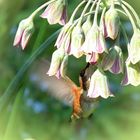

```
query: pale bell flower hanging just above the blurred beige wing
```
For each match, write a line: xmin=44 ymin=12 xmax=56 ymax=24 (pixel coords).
xmin=47 ymin=48 xmax=67 ymax=78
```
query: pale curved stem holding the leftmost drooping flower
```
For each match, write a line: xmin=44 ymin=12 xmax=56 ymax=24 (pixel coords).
xmin=29 ymin=0 xmax=56 ymax=19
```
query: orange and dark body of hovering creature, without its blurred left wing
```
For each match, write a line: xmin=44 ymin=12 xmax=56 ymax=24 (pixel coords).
xmin=66 ymin=63 xmax=98 ymax=120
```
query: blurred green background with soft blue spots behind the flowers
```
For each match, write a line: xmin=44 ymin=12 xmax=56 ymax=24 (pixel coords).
xmin=0 ymin=0 xmax=140 ymax=140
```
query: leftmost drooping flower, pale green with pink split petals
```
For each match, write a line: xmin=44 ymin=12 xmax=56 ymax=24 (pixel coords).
xmin=13 ymin=17 xmax=34 ymax=50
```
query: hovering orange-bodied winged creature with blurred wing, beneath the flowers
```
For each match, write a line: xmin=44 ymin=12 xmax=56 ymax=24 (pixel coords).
xmin=30 ymin=60 xmax=98 ymax=121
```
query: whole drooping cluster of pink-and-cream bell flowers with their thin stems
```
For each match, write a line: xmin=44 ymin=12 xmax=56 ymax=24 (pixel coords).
xmin=14 ymin=0 xmax=140 ymax=113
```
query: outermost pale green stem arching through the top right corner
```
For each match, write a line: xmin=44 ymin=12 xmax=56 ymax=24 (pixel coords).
xmin=122 ymin=0 xmax=140 ymax=26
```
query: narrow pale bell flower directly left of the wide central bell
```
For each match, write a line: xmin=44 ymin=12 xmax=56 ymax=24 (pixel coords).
xmin=70 ymin=25 xmax=85 ymax=58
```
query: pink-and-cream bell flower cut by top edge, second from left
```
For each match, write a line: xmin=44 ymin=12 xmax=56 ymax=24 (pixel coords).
xmin=41 ymin=0 xmax=67 ymax=25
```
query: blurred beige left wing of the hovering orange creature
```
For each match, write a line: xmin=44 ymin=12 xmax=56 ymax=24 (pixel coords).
xmin=30 ymin=60 xmax=74 ymax=106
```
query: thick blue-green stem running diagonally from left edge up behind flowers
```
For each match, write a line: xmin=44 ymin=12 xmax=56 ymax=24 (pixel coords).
xmin=0 ymin=30 xmax=60 ymax=113
